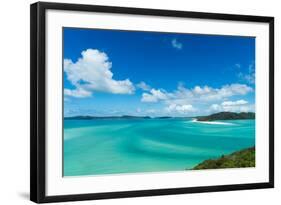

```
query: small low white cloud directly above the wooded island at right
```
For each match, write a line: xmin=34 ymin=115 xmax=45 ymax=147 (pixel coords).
xmin=209 ymin=100 xmax=255 ymax=112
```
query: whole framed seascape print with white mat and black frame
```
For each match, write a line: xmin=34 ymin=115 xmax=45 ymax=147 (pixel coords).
xmin=30 ymin=2 xmax=274 ymax=203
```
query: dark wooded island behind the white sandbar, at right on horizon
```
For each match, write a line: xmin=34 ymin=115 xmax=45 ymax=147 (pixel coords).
xmin=195 ymin=112 xmax=255 ymax=121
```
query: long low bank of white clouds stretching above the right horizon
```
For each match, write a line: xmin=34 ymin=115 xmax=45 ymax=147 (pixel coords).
xmin=141 ymin=84 xmax=253 ymax=114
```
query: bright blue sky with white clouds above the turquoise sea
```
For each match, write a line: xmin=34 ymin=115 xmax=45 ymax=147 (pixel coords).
xmin=63 ymin=28 xmax=255 ymax=116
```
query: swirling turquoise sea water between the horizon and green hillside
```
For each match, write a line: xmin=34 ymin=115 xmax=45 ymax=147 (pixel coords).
xmin=64 ymin=119 xmax=255 ymax=176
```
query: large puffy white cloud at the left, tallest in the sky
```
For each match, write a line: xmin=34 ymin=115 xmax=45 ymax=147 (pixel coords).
xmin=64 ymin=49 xmax=135 ymax=97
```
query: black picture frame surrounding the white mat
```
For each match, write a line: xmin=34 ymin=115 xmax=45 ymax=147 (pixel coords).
xmin=30 ymin=2 xmax=274 ymax=203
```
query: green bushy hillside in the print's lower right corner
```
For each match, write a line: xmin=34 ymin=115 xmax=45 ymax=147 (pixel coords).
xmin=192 ymin=147 xmax=255 ymax=170
